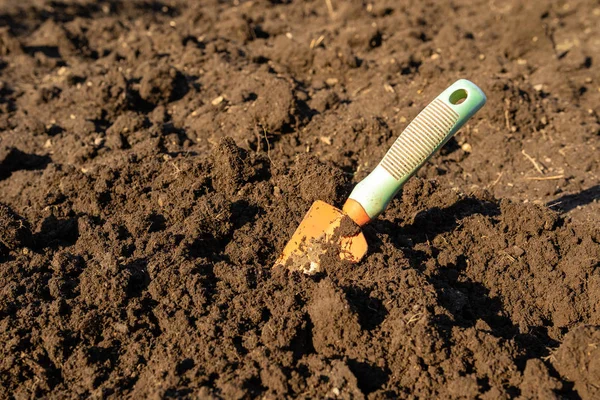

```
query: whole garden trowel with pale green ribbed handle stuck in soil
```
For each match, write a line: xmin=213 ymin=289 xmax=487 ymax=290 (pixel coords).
xmin=275 ymin=79 xmax=486 ymax=275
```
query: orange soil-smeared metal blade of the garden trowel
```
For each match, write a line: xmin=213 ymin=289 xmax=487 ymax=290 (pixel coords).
xmin=275 ymin=200 xmax=367 ymax=275
